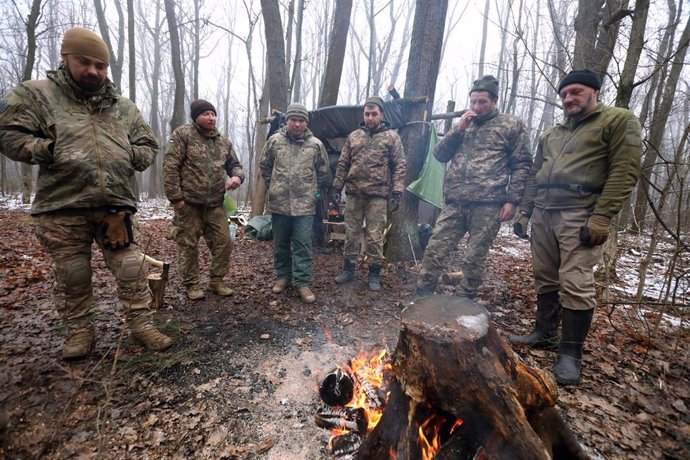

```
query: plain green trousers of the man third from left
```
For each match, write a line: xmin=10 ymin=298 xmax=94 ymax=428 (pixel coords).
xmin=271 ymin=213 xmax=314 ymax=287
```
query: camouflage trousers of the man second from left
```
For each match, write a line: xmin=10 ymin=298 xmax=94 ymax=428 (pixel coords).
xmin=173 ymin=203 xmax=230 ymax=288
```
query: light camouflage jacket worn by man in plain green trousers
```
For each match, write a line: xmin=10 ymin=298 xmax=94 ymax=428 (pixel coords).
xmin=259 ymin=127 xmax=332 ymax=216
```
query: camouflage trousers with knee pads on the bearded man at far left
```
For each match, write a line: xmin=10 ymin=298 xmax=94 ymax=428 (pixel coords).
xmin=33 ymin=209 xmax=151 ymax=328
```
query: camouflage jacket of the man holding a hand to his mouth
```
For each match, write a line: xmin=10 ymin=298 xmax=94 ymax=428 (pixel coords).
xmin=434 ymin=111 xmax=532 ymax=205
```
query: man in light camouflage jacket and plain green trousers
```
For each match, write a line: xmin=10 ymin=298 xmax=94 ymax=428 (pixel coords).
xmin=259 ymin=103 xmax=332 ymax=303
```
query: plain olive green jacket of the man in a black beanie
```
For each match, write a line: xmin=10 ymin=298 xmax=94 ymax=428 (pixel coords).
xmin=520 ymin=104 xmax=642 ymax=217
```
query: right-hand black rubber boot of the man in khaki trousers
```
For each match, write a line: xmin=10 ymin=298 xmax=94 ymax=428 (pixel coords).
xmin=553 ymin=308 xmax=594 ymax=385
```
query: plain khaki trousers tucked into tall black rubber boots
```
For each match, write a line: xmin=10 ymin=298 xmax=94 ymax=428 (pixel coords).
xmin=530 ymin=208 xmax=603 ymax=310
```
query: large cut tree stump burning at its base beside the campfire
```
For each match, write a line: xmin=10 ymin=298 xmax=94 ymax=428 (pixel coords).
xmin=359 ymin=296 xmax=587 ymax=460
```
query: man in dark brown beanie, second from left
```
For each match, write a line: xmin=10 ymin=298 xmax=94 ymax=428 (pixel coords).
xmin=163 ymin=99 xmax=244 ymax=300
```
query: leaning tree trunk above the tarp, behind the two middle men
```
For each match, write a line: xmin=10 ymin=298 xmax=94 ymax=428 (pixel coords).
xmin=319 ymin=0 xmax=352 ymax=107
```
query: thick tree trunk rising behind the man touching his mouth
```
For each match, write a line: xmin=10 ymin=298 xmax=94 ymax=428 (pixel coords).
xmin=386 ymin=0 xmax=448 ymax=261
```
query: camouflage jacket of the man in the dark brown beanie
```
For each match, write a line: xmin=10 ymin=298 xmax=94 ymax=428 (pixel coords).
xmin=163 ymin=122 xmax=244 ymax=207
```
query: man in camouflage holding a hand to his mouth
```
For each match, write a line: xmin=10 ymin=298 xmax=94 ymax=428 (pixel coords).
xmin=416 ymin=75 xmax=532 ymax=297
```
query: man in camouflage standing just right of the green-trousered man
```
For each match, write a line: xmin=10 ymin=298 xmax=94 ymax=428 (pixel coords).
xmin=332 ymin=96 xmax=405 ymax=291
